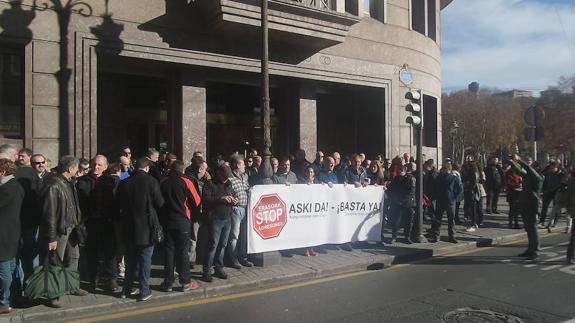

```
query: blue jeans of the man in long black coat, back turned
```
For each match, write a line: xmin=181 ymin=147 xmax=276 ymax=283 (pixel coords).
xmin=123 ymin=245 xmax=154 ymax=295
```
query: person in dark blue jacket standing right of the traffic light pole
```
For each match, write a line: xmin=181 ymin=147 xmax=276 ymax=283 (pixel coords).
xmin=429 ymin=163 xmax=463 ymax=243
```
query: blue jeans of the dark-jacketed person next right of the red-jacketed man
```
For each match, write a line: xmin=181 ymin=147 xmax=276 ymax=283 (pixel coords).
xmin=204 ymin=217 xmax=231 ymax=274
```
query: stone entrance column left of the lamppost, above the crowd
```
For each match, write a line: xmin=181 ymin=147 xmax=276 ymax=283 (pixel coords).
xmin=180 ymin=75 xmax=207 ymax=164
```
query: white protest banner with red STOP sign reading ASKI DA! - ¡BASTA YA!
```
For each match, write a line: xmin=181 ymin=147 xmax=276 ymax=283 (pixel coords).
xmin=247 ymin=184 xmax=384 ymax=253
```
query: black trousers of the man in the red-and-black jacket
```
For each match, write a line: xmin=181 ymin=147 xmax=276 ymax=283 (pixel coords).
xmin=164 ymin=225 xmax=191 ymax=286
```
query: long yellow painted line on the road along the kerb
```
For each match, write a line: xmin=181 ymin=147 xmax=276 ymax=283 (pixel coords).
xmin=69 ymin=234 xmax=564 ymax=323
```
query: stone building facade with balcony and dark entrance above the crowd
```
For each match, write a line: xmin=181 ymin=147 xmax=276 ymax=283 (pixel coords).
xmin=0 ymin=0 xmax=451 ymax=166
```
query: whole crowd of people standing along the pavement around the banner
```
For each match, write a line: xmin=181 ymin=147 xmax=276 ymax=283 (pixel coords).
xmin=0 ymin=144 xmax=575 ymax=313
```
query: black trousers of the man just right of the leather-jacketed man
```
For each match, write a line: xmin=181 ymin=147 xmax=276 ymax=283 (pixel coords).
xmin=86 ymin=219 xmax=118 ymax=283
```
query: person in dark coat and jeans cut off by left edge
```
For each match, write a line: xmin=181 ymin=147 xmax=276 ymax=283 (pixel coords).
xmin=0 ymin=159 xmax=24 ymax=314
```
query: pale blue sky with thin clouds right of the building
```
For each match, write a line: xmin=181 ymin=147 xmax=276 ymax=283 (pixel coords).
xmin=442 ymin=0 xmax=575 ymax=91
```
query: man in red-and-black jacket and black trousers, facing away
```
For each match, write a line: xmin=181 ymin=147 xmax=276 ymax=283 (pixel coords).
xmin=161 ymin=160 xmax=201 ymax=292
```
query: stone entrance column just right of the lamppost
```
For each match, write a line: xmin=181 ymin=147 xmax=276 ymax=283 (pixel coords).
xmin=299 ymin=84 xmax=317 ymax=158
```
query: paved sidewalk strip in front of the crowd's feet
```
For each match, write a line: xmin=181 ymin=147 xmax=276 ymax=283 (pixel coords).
xmin=0 ymin=198 xmax=565 ymax=323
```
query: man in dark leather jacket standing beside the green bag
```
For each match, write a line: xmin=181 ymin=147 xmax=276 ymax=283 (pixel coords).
xmin=40 ymin=156 xmax=88 ymax=307
